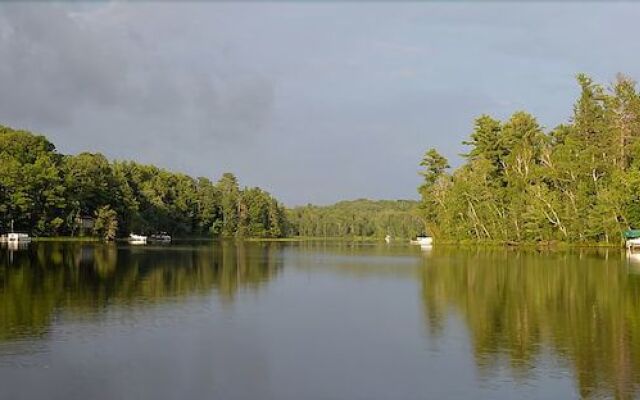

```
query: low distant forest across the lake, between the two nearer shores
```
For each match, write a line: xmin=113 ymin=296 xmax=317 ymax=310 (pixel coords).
xmin=287 ymin=199 xmax=424 ymax=238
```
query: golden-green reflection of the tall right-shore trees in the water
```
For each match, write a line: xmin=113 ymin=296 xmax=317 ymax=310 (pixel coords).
xmin=422 ymin=248 xmax=640 ymax=398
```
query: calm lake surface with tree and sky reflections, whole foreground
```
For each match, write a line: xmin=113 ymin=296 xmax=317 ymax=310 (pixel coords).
xmin=0 ymin=242 xmax=640 ymax=400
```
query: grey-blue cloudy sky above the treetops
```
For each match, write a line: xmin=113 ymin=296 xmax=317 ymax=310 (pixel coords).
xmin=0 ymin=1 xmax=640 ymax=206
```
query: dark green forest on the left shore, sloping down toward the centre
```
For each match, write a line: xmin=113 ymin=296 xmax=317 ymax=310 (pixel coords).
xmin=0 ymin=125 xmax=286 ymax=239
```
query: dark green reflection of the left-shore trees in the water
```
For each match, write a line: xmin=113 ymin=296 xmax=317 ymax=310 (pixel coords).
xmin=0 ymin=241 xmax=281 ymax=341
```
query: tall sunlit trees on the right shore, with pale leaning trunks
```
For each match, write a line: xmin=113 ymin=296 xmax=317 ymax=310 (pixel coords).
xmin=419 ymin=74 xmax=640 ymax=243
